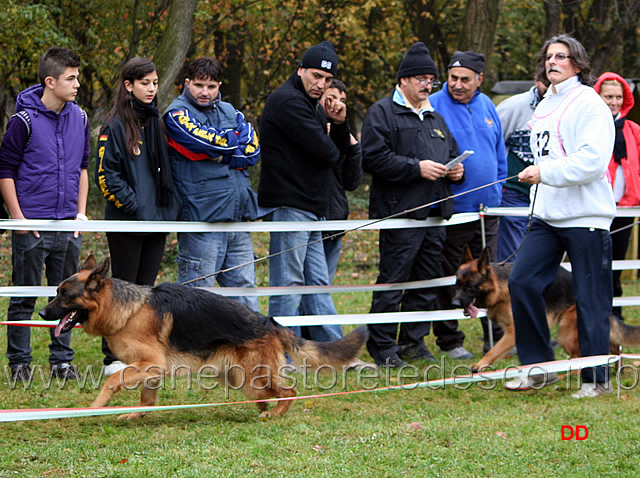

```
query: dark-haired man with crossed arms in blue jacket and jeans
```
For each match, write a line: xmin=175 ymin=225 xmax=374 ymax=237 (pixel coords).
xmin=164 ymin=57 xmax=260 ymax=311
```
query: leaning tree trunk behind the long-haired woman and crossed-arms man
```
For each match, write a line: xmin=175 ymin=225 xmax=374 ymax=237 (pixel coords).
xmin=154 ymin=0 xmax=198 ymax=111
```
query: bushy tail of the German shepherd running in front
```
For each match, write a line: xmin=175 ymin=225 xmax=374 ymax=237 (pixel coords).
xmin=276 ymin=325 xmax=369 ymax=369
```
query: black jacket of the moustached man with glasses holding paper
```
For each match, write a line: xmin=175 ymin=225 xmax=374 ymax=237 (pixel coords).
xmin=362 ymin=92 xmax=462 ymax=219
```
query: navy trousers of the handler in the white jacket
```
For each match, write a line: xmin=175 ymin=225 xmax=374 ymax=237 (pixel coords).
xmin=509 ymin=219 xmax=613 ymax=383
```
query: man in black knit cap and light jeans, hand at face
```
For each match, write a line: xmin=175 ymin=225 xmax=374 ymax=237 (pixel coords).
xmin=258 ymin=41 xmax=350 ymax=341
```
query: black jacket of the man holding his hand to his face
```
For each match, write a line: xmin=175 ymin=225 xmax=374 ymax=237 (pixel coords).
xmin=258 ymin=71 xmax=349 ymax=217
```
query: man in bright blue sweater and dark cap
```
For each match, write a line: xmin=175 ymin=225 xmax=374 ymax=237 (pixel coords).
xmin=431 ymin=51 xmax=507 ymax=358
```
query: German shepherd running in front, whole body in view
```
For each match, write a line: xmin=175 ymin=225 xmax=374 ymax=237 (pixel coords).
xmin=40 ymin=254 xmax=367 ymax=419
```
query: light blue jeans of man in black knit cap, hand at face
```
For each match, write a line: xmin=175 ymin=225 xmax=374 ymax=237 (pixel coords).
xmin=265 ymin=207 xmax=342 ymax=342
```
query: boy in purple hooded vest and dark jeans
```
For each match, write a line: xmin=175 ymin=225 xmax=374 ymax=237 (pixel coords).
xmin=0 ymin=47 xmax=89 ymax=382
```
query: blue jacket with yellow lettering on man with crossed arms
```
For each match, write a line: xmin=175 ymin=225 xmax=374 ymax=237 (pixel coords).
xmin=164 ymin=94 xmax=260 ymax=222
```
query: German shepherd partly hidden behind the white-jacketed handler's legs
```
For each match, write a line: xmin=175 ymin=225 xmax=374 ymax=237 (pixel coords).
xmin=452 ymin=247 xmax=640 ymax=371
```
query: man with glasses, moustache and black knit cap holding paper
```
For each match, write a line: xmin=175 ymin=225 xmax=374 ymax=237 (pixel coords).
xmin=362 ymin=42 xmax=464 ymax=367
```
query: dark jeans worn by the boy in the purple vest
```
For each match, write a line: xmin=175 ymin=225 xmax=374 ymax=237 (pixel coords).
xmin=7 ymin=231 xmax=82 ymax=368
